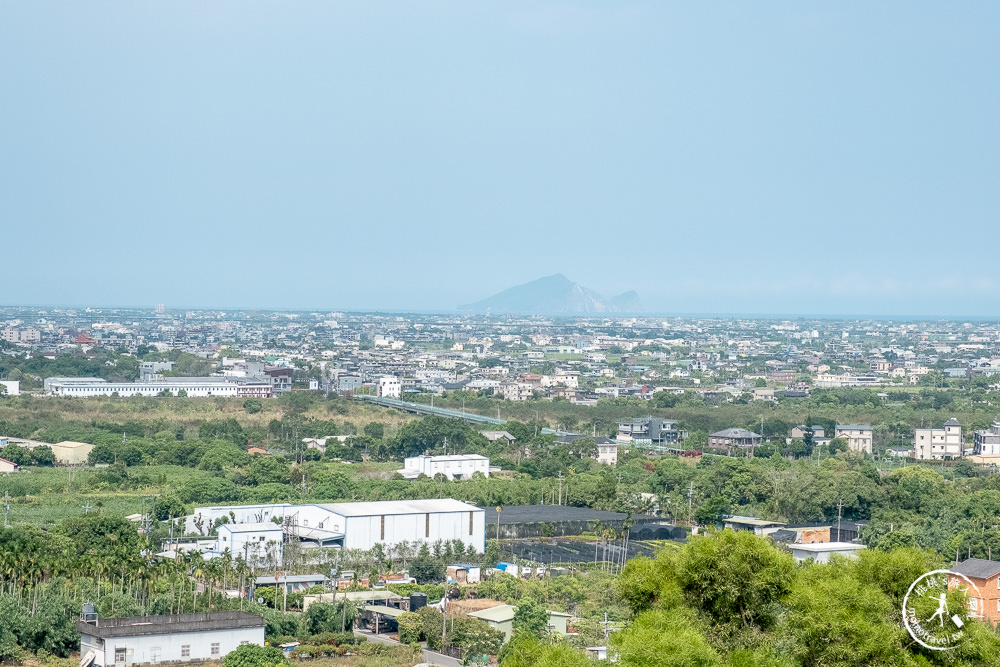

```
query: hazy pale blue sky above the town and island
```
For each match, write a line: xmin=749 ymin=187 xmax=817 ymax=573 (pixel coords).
xmin=0 ymin=0 xmax=1000 ymax=316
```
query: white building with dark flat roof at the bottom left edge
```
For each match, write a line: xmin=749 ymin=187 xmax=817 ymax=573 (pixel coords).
xmin=76 ymin=605 xmax=264 ymax=667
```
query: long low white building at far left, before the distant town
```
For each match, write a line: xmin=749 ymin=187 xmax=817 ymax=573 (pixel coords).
xmin=42 ymin=376 xmax=272 ymax=398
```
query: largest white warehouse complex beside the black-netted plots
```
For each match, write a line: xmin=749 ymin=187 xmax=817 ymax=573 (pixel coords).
xmin=185 ymin=498 xmax=486 ymax=556
